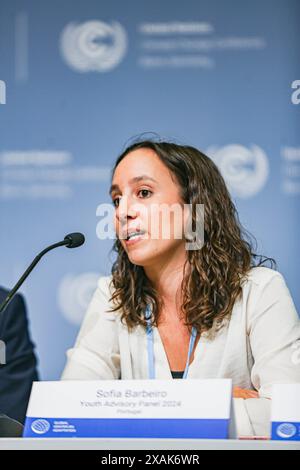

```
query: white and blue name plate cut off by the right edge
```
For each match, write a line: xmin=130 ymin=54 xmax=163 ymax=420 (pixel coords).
xmin=271 ymin=383 xmax=300 ymax=441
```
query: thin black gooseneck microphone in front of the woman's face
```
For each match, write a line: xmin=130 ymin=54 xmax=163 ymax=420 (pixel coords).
xmin=0 ymin=232 xmax=85 ymax=315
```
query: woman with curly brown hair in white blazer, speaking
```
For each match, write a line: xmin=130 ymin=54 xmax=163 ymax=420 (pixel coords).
xmin=62 ymin=141 xmax=300 ymax=435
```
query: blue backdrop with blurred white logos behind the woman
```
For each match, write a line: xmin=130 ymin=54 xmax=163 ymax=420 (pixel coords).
xmin=0 ymin=0 xmax=300 ymax=380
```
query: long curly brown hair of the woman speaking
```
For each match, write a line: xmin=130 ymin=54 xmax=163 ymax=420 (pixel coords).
xmin=109 ymin=140 xmax=276 ymax=334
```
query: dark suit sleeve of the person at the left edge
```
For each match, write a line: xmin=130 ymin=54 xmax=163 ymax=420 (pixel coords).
xmin=0 ymin=288 xmax=38 ymax=423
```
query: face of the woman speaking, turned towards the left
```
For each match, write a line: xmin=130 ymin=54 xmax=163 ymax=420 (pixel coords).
xmin=111 ymin=148 xmax=185 ymax=267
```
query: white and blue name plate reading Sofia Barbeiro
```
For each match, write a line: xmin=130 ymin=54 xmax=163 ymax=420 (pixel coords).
xmin=23 ymin=379 xmax=232 ymax=439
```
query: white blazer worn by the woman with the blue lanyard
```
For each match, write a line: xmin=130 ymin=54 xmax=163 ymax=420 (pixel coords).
xmin=62 ymin=267 xmax=300 ymax=436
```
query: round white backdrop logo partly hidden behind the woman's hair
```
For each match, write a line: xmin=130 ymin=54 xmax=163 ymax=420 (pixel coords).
xmin=207 ymin=144 xmax=269 ymax=198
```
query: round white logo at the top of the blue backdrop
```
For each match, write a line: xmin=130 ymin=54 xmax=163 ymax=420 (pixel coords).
xmin=60 ymin=20 xmax=127 ymax=72
